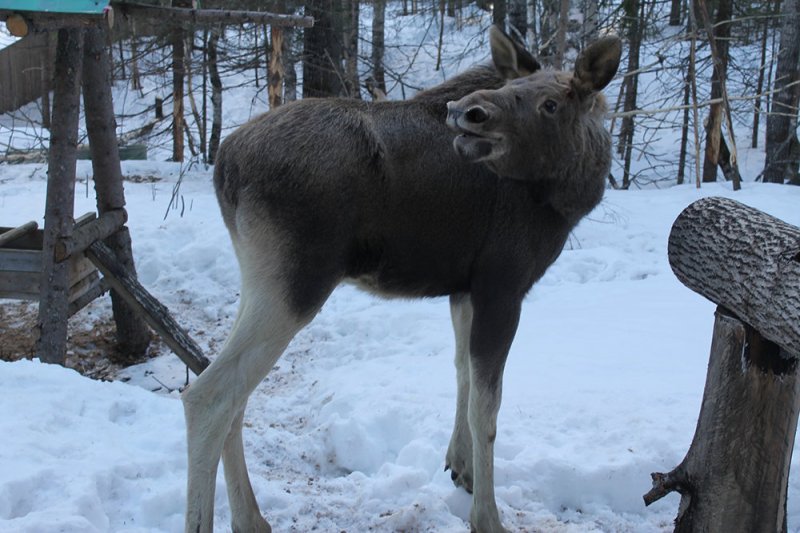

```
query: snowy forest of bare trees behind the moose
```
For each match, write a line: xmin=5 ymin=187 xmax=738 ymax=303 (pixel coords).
xmin=0 ymin=0 xmax=800 ymax=189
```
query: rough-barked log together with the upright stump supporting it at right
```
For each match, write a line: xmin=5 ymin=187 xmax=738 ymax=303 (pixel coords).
xmin=644 ymin=198 xmax=800 ymax=533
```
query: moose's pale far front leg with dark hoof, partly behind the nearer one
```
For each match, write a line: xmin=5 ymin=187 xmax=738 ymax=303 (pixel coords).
xmin=445 ymin=294 xmax=472 ymax=493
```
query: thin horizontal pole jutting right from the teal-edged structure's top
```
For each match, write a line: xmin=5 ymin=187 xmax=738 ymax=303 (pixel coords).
xmin=113 ymin=2 xmax=314 ymax=28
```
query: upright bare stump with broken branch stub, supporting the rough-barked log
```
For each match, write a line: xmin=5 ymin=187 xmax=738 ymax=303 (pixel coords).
xmin=644 ymin=308 xmax=800 ymax=533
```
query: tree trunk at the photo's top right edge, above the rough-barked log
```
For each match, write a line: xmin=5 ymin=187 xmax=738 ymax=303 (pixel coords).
xmin=764 ymin=0 xmax=800 ymax=183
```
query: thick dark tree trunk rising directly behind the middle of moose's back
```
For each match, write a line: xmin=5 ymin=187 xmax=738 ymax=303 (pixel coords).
xmin=303 ymin=0 xmax=344 ymax=98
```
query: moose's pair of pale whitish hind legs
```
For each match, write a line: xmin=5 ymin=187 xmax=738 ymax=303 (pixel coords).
xmin=183 ymin=268 xmax=321 ymax=533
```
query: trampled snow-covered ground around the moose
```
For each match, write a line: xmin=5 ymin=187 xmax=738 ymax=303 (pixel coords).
xmin=0 ymin=162 xmax=800 ymax=533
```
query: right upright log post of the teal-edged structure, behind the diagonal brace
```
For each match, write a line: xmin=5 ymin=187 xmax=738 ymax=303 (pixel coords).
xmin=83 ymin=28 xmax=150 ymax=361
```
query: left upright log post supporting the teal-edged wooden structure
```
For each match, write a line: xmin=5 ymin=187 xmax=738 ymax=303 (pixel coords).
xmin=36 ymin=28 xmax=83 ymax=364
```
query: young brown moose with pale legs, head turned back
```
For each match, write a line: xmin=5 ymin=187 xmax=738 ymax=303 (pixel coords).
xmin=182 ymin=27 xmax=621 ymax=533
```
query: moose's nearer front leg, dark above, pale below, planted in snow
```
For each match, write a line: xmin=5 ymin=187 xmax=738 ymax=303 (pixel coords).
xmin=467 ymin=293 xmax=521 ymax=533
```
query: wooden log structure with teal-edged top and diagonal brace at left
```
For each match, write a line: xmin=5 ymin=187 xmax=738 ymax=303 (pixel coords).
xmin=0 ymin=0 xmax=313 ymax=373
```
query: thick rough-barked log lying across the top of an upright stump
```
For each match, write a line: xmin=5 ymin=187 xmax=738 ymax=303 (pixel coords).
xmin=668 ymin=198 xmax=800 ymax=357
